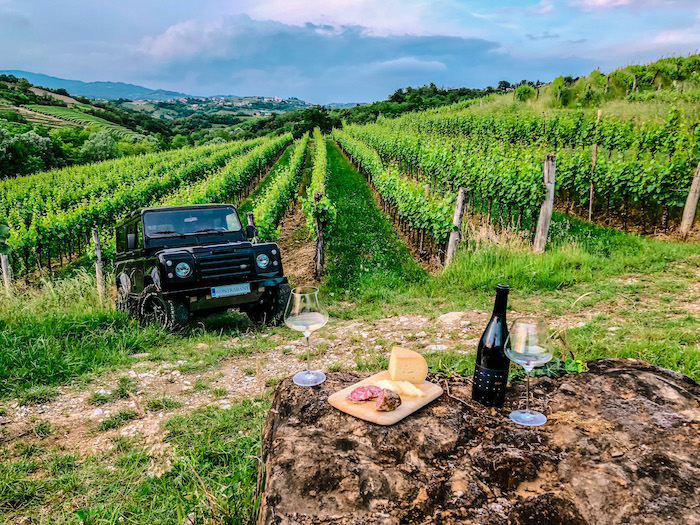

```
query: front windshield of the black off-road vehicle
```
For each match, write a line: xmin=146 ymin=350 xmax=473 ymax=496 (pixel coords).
xmin=143 ymin=208 xmax=241 ymax=237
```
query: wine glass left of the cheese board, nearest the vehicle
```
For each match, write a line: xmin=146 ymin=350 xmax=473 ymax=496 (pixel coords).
xmin=284 ymin=286 xmax=328 ymax=386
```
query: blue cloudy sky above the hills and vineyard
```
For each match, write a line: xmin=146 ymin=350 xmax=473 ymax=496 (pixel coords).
xmin=0 ymin=0 xmax=700 ymax=103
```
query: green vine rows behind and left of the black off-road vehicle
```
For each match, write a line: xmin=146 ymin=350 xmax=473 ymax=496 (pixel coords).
xmin=5 ymin=135 xmax=291 ymax=275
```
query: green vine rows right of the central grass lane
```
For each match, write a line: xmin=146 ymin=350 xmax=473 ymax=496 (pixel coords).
xmin=335 ymin=102 xmax=700 ymax=254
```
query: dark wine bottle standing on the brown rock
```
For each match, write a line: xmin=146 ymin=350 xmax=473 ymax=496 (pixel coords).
xmin=472 ymin=284 xmax=510 ymax=406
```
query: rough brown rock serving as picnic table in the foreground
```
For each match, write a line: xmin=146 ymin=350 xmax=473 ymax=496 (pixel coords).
xmin=258 ymin=359 xmax=700 ymax=525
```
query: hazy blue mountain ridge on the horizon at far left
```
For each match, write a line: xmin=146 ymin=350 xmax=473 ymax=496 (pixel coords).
xmin=0 ymin=70 xmax=191 ymax=100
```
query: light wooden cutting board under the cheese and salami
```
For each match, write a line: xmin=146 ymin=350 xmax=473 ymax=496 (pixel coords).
xmin=328 ymin=370 xmax=442 ymax=425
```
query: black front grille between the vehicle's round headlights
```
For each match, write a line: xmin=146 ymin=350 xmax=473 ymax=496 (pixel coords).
xmin=193 ymin=248 xmax=255 ymax=283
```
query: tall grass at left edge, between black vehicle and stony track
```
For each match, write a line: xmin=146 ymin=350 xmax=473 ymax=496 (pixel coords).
xmin=0 ymin=272 xmax=172 ymax=403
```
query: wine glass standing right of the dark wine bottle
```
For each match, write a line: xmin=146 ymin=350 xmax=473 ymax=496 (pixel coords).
xmin=506 ymin=317 xmax=553 ymax=427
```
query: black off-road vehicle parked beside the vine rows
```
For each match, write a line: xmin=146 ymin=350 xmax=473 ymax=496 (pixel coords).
xmin=115 ymin=204 xmax=290 ymax=330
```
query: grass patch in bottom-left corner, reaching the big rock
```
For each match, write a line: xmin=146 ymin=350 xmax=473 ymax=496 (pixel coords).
xmin=0 ymin=400 xmax=269 ymax=525
